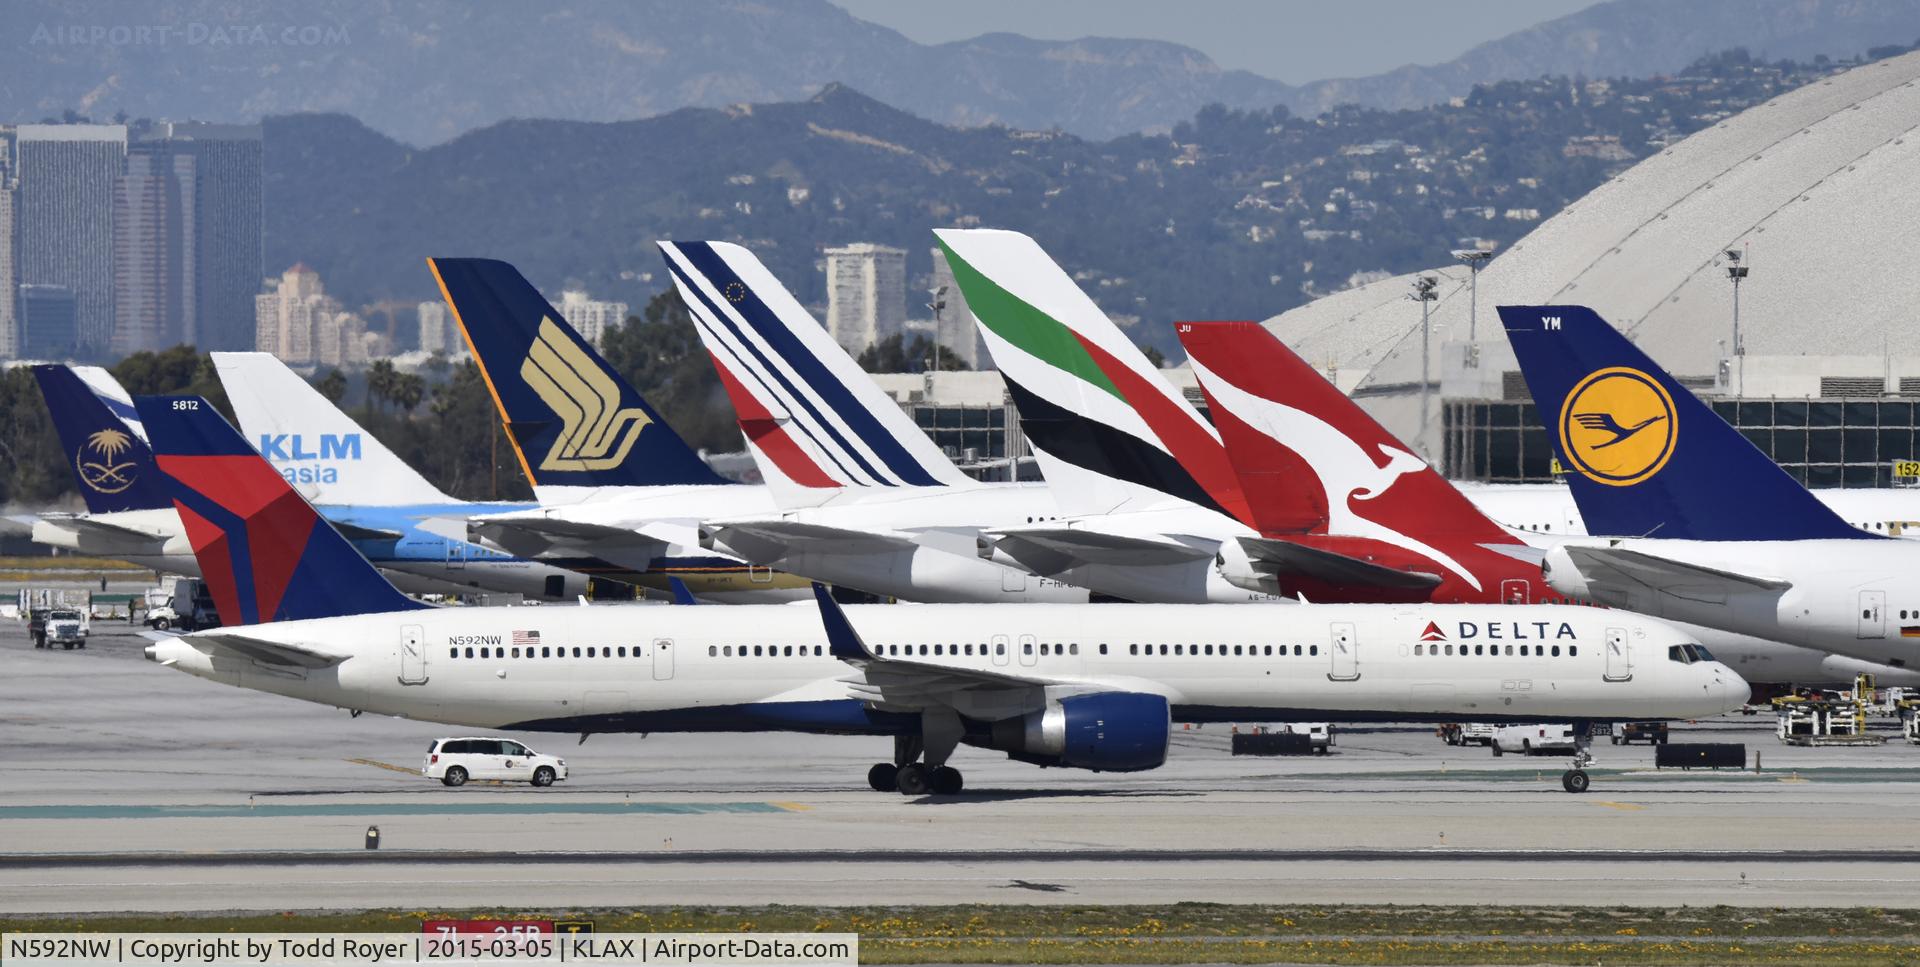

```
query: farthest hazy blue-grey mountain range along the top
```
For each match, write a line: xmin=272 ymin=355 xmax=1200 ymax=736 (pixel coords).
xmin=15 ymin=0 xmax=1920 ymax=144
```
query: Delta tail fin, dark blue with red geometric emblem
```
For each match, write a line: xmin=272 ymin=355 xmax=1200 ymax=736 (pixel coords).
xmin=134 ymin=397 xmax=424 ymax=624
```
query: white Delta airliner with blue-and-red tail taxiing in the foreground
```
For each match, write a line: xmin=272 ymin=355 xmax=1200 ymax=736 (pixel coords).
xmin=136 ymin=397 xmax=1745 ymax=792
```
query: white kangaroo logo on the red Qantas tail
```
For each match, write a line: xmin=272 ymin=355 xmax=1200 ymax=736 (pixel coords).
xmin=1192 ymin=361 xmax=1480 ymax=591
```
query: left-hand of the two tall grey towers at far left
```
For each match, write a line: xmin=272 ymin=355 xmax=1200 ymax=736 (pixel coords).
xmin=13 ymin=125 xmax=127 ymax=355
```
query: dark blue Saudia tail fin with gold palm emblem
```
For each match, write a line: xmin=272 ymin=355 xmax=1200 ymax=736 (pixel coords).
xmin=33 ymin=366 xmax=173 ymax=514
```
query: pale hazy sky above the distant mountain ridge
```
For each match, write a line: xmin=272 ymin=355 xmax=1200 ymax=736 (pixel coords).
xmin=833 ymin=0 xmax=1596 ymax=84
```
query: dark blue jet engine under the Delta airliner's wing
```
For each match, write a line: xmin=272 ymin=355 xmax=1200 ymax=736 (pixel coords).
xmin=987 ymin=693 xmax=1173 ymax=771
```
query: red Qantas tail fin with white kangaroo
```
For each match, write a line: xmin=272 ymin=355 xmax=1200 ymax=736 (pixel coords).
xmin=1177 ymin=322 xmax=1517 ymax=543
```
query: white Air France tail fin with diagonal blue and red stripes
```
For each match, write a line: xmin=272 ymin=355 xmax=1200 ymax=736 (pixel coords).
xmin=660 ymin=242 xmax=975 ymax=487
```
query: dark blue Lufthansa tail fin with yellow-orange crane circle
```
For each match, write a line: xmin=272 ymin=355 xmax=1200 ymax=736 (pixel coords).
xmin=1500 ymin=305 xmax=1872 ymax=541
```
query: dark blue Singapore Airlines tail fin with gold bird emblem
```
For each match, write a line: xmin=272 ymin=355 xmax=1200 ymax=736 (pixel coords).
xmin=426 ymin=259 xmax=726 ymax=487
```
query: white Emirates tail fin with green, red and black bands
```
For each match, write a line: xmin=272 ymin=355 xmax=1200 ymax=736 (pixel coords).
xmin=933 ymin=228 xmax=1254 ymax=526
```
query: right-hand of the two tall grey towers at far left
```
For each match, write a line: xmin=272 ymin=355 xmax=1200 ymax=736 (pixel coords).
xmin=113 ymin=121 xmax=261 ymax=351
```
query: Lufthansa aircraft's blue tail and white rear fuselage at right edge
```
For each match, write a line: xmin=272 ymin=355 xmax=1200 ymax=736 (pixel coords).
xmin=1500 ymin=305 xmax=1920 ymax=668
